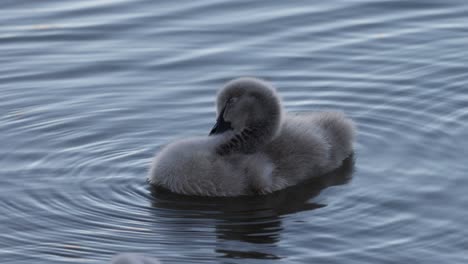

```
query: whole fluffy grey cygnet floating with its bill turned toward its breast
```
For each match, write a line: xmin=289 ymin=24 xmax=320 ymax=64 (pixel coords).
xmin=149 ymin=78 xmax=354 ymax=196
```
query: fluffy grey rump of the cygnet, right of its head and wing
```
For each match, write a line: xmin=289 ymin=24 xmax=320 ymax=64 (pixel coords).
xmin=262 ymin=112 xmax=354 ymax=190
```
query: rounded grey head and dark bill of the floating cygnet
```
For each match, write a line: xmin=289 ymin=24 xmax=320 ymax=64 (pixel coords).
xmin=210 ymin=78 xmax=282 ymax=155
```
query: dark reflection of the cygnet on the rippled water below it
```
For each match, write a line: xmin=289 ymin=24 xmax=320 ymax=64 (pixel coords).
xmin=151 ymin=156 xmax=354 ymax=259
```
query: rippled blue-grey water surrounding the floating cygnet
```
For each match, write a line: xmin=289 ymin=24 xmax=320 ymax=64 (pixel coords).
xmin=0 ymin=0 xmax=468 ymax=264
